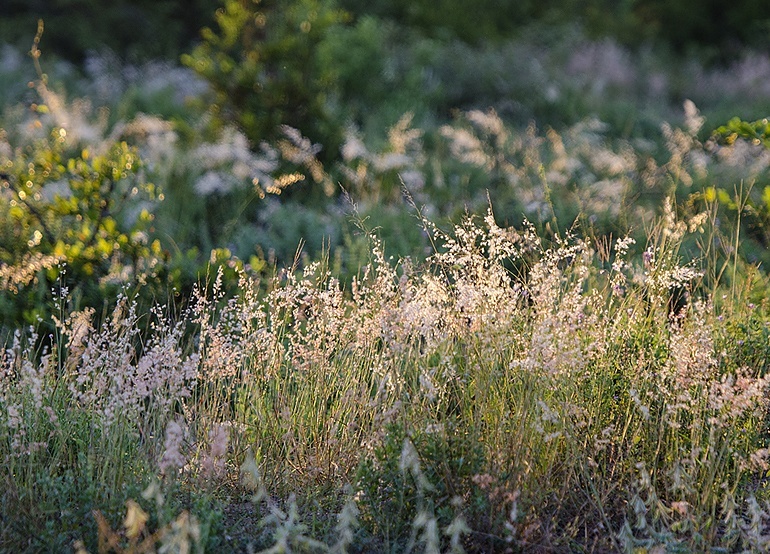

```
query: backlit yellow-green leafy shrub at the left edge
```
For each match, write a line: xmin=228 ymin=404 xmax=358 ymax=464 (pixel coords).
xmin=0 ymin=125 xmax=164 ymax=326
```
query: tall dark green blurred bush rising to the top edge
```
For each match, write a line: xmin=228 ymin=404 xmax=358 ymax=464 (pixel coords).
xmin=182 ymin=0 xmax=346 ymax=159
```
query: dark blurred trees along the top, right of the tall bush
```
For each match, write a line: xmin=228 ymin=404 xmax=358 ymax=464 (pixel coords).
xmin=340 ymin=0 xmax=770 ymax=54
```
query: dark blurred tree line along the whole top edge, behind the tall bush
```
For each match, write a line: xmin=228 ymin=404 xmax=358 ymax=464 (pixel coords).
xmin=0 ymin=0 xmax=770 ymax=62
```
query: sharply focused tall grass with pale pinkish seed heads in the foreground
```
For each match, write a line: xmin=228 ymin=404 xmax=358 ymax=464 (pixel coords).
xmin=0 ymin=196 xmax=770 ymax=552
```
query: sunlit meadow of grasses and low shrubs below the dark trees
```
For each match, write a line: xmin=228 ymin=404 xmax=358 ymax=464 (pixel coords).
xmin=0 ymin=7 xmax=770 ymax=554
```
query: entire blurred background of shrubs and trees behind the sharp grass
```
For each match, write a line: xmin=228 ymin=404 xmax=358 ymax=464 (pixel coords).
xmin=0 ymin=0 xmax=770 ymax=324
